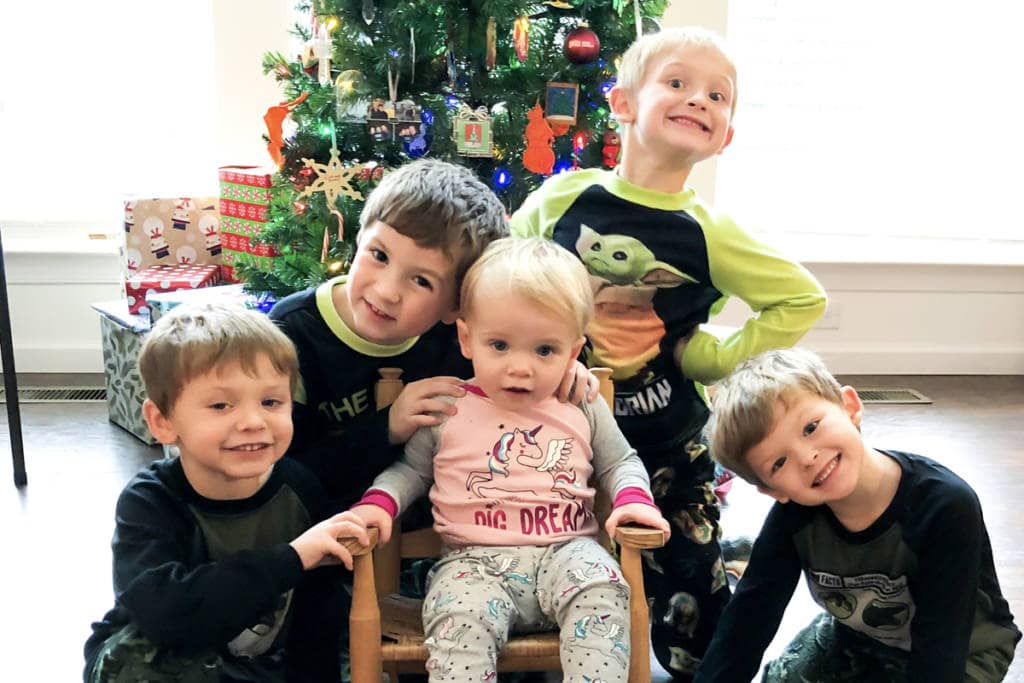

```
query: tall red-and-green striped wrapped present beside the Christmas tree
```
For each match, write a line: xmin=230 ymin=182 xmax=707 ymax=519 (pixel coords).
xmin=219 ymin=166 xmax=280 ymax=282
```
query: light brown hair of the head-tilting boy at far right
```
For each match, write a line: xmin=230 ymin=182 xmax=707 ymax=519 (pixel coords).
xmin=707 ymin=348 xmax=843 ymax=487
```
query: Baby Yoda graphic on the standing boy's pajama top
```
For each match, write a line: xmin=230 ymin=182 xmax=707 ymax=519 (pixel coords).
xmin=575 ymin=223 xmax=697 ymax=381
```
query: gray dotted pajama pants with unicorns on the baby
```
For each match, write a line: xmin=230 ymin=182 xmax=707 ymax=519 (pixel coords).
xmin=423 ymin=539 xmax=630 ymax=683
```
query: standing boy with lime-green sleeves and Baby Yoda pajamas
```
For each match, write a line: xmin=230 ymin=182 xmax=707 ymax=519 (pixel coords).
xmin=512 ymin=28 xmax=825 ymax=680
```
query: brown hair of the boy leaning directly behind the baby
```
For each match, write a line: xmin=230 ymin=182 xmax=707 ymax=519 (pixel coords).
xmin=356 ymin=159 xmax=509 ymax=301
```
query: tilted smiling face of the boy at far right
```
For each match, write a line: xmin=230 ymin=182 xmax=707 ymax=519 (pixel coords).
xmin=746 ymin=387 xmax=867 ymax=506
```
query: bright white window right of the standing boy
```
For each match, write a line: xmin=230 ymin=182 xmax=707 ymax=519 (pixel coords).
xmin=716 ymin=0 xmax=1024 ymax=259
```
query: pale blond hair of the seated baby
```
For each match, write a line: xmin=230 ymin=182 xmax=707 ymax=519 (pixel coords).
xmin=462 ymin=238 xmax=594 ymax=336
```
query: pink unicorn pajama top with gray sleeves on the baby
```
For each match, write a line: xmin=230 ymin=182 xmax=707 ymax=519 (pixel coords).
xmin=361 ymin=385 xmax=651 ymax=548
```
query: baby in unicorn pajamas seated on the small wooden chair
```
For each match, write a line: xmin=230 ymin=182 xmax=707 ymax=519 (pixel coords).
xmin=352 ymin=239 xmax=669 ymax=683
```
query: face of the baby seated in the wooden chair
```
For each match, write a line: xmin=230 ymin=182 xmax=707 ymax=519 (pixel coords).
xmin=457 ymin=292 xmax=584 ymax=410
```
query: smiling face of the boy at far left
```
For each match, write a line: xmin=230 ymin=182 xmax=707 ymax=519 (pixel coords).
xmin=145 ymin=355 xmax=292 ymax=500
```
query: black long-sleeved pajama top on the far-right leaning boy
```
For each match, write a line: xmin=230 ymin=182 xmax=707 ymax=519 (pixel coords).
xmin=694 ymin=451 xmax=1021 ymax=683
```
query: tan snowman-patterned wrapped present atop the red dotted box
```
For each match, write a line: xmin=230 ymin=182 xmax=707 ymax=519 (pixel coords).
xmin=123 ymin=197 xmax=221 ymax=278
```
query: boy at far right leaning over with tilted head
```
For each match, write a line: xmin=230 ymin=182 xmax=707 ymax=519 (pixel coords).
xmin=696 ymin=348 xmax=1021 ymax=683
